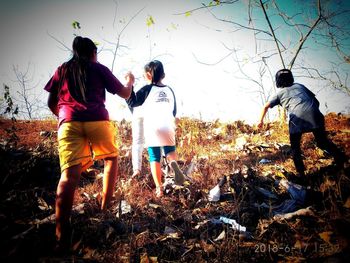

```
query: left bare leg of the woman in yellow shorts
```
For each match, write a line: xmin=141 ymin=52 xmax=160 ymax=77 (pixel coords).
xmin=56 ymin=164 xmax=81 ymax=241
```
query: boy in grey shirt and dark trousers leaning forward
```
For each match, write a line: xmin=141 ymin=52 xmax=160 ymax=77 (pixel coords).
xmin=258 ymin=69 xmax=347 ymax=179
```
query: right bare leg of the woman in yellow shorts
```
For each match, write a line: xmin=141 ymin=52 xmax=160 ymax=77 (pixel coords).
xmin=101 ymin=157 xmax=118 ymax=211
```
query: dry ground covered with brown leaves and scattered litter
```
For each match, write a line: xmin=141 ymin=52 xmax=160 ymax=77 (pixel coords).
xmin=0 ymin=113 xmax=350 ymax=262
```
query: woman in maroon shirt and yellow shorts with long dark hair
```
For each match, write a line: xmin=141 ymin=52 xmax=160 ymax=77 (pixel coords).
xmin=45 ymin=36 xmax=134 ymax=251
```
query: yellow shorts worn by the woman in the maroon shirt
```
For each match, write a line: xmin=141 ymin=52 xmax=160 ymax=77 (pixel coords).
xmin=58 ymin=121 xmax=118 ymax=171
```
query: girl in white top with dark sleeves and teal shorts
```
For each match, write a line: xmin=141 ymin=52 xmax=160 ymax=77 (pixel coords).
xmin=127 ymin=60 xmax=185 ymax=197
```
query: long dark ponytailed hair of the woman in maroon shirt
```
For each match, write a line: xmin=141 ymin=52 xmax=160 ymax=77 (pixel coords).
xmin=61 ymin=36 xmax=97 ymax=102
